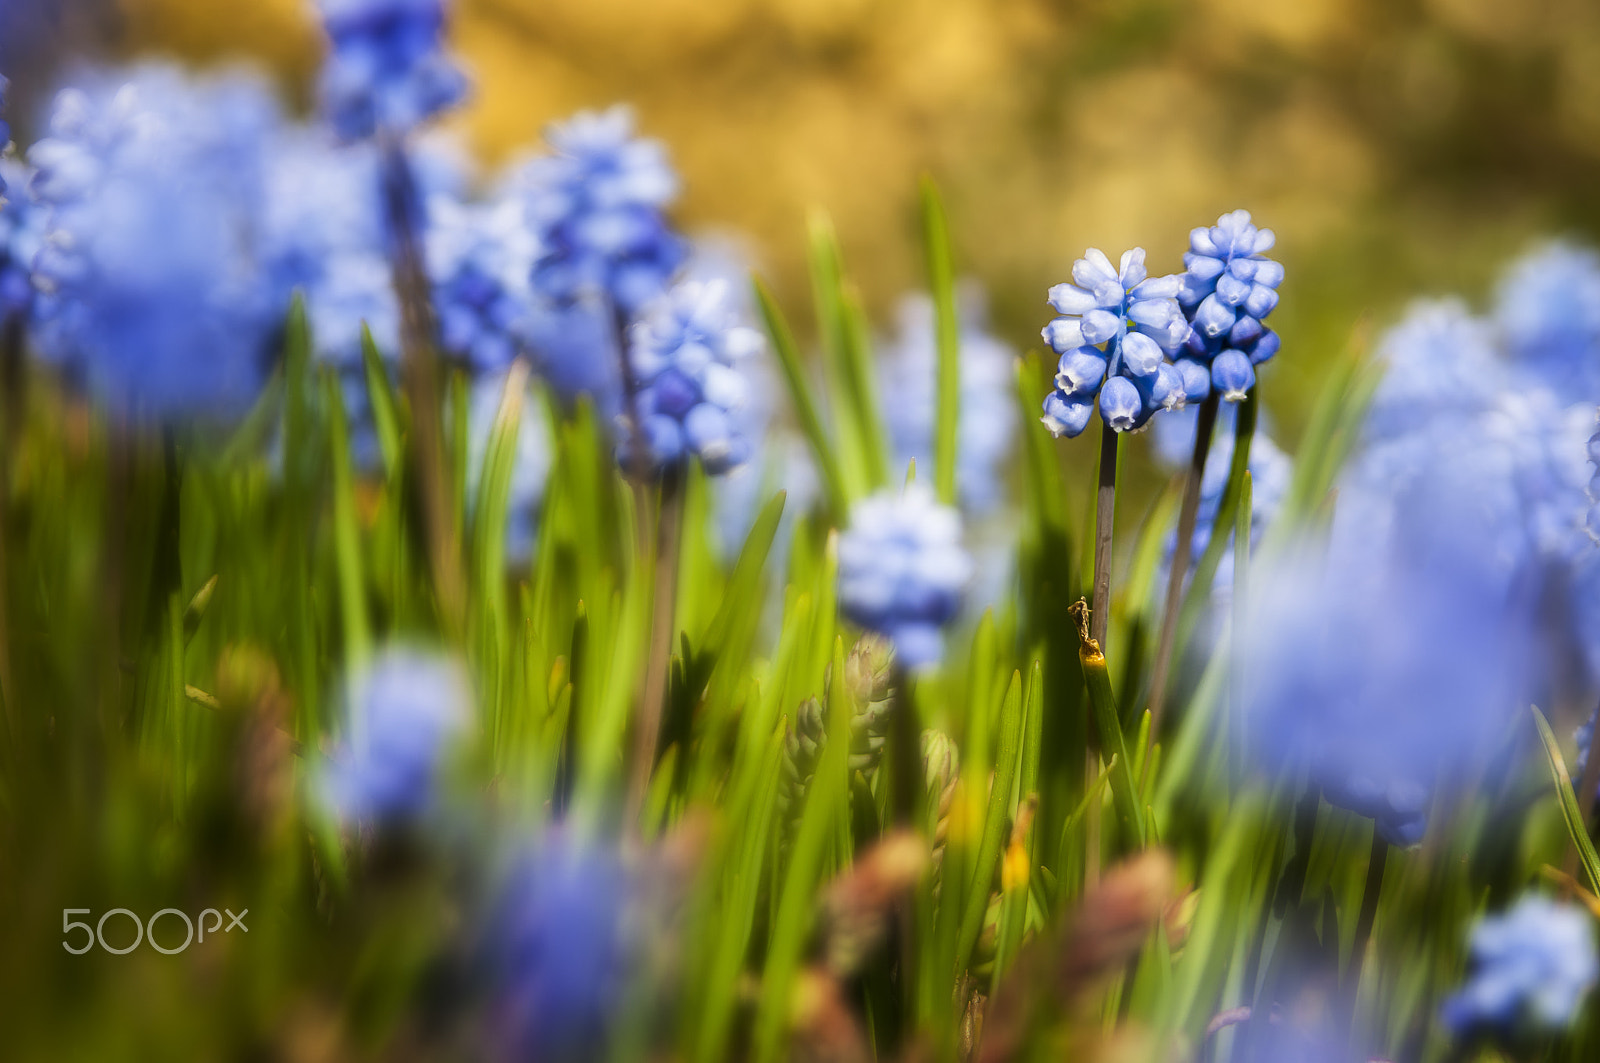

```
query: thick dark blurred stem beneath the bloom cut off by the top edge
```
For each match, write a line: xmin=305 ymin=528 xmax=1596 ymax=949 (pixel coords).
xmin=384 ymin=138 xmax=466 ymax=637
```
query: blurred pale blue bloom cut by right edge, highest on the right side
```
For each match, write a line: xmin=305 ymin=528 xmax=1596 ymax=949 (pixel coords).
xmin=1494 ymin=242 xmax=1600 ymax=402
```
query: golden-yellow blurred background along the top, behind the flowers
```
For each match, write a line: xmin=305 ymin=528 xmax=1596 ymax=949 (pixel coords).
xmin=25 ymin=0 xmax=1600 ymax=442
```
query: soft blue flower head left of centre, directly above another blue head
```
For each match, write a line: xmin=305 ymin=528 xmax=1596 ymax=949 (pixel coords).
xmin=515 ymin=106 xmax=688 ymax=317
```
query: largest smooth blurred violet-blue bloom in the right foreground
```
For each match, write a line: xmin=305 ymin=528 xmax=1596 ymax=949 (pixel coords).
xmin=1240 ymin=482 xmax=1533 ymax=844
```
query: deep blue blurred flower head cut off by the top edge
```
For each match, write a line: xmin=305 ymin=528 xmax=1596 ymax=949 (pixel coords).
xmin=318 ymin=0 xmax=467 ymax=141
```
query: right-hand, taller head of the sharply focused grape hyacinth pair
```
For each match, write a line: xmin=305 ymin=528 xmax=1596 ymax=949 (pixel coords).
xmin=1178 ymin=210 xmax=1283 ymax=402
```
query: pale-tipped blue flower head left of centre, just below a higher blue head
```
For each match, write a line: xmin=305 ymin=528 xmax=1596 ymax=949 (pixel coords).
xmin=624 ymin=280 xmax=762 ymax=474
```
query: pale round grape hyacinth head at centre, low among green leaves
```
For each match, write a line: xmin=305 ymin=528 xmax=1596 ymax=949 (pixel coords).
xmin=838 ymin=483 xmax=973 ymax=668
